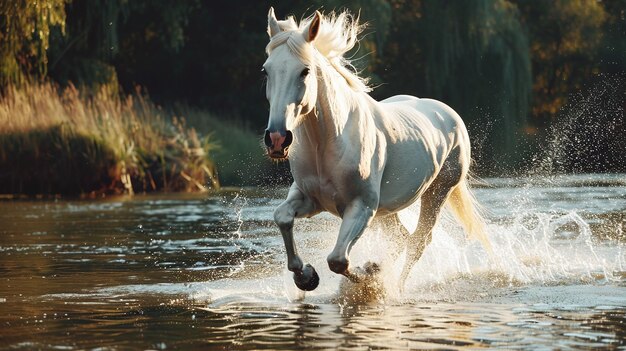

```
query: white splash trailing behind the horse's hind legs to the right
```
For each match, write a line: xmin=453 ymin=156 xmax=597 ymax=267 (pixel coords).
xmin=370 ymin=205 xmax=626 ymax=300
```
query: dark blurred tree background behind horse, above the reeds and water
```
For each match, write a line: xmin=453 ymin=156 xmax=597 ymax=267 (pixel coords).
xmin=0 ymin=0 xmax=626 ymax=188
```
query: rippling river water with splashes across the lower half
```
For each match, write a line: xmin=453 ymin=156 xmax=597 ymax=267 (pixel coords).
xmin=0 ymin=175 xmax=626 ymax=350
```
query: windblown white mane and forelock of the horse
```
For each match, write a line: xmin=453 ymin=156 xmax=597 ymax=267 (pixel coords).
xmin=265 ymin=11 xmax=371 ymax=92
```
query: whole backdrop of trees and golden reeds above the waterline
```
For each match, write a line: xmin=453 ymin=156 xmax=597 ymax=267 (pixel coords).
xmin=0 ymin=0 xmax=626 ymax=198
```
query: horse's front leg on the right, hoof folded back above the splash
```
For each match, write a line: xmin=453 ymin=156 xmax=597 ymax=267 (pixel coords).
xmin=327 ymin=201 xmax=376 ymax=282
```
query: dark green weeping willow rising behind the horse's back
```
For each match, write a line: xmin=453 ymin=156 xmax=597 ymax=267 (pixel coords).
xmin=382 ymin=0 xmax=532 ymax=170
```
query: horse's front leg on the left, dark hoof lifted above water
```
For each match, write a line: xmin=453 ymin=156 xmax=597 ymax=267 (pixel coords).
xmin=274 ymin=184 xmax=320 ymax=291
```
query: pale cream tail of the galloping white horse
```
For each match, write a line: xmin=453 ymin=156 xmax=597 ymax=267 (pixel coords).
xmin=448 ymin=179 xmax=491 ymax=252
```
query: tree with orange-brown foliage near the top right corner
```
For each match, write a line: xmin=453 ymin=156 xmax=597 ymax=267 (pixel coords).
xmin=515 ymin=0 xmax=604 ymax=127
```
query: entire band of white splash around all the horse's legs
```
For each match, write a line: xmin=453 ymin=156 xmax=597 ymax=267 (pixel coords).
xmin=195 ymin=182 xmax=626 ymax=306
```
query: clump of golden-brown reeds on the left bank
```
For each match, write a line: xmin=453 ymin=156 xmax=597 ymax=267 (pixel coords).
xmin=0 ymin=82 xmax=219 ymax=195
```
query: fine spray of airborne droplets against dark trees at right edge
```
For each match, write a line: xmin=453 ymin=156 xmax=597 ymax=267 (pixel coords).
xmin=528 ymin=74 xmax=626 ymax=175
